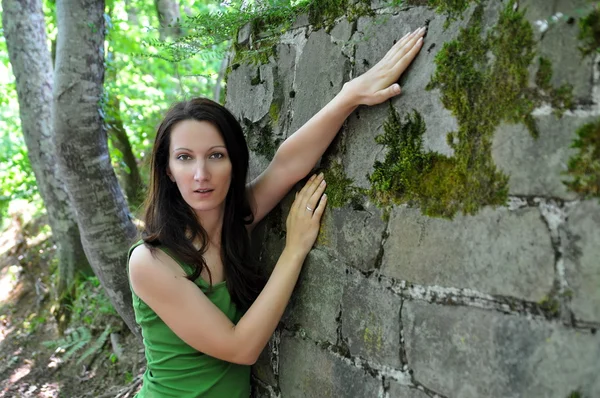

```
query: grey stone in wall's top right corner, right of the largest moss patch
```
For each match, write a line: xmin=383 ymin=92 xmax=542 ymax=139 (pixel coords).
xmin=519 ymin=0 xmax=594 ymax=103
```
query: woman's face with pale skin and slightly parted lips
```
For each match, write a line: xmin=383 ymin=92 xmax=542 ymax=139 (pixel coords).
xmin=167 ymin=120 xmax=231 ymax=215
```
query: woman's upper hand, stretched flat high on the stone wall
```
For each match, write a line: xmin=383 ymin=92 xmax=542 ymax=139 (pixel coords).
xmin=342 ymin=27 xmax=426 ymax=105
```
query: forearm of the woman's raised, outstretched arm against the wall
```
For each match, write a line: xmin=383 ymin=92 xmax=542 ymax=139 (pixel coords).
xmin=273 ymin=86 xmax=358 ymax=180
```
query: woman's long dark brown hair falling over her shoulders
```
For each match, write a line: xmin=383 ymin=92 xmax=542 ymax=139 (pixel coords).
xmin=142 ymin=98 xmax=264 ymax=309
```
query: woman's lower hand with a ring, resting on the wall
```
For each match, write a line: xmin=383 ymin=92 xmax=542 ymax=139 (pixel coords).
xmin=286 ymin=173 xmax=327 ymax=256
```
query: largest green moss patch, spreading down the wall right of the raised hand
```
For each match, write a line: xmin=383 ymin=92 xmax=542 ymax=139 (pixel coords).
xmin=369 ymin=1 xmax=571 ymax=218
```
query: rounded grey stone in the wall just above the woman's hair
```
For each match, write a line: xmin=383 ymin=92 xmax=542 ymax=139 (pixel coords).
xmin=225 ymin=64 xmax=273 ymax=123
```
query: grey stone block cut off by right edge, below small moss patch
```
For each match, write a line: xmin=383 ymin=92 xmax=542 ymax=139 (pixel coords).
xmin=561 ymin=200 xmax=600 ymax=322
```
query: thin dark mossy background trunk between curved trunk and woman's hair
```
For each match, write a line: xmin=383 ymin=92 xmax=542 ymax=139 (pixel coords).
xmin=106 ymin=96 xmax=143 ymax=208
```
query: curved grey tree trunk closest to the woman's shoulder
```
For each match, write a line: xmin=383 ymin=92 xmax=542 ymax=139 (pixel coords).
xmin=53 ymin=0 xmax=139 ymax=336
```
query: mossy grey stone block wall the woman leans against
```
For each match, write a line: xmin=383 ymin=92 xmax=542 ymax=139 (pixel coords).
xmin=226 ymin=0 xmax=600 ymax=398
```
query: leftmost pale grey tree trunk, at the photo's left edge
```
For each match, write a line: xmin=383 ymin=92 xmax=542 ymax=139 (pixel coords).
xmin=2 ymin=0 xmax=93 ymax=297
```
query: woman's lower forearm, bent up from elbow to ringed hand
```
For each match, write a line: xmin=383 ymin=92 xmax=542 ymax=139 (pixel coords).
xmin=234 ymin=249 xmax=306 ymax=364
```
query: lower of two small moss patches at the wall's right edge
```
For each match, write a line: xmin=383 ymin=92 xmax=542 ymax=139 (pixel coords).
xmin=565 ymin=120 xmax=600 ymax=198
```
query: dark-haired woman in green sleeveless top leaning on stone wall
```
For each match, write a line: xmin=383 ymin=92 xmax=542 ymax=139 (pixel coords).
xmin=128 ymin=28 xmax=425 ymax=398
